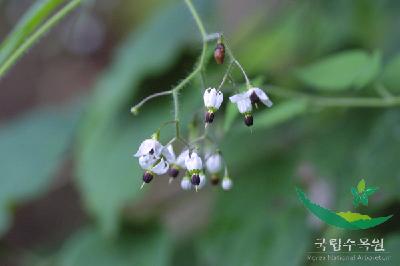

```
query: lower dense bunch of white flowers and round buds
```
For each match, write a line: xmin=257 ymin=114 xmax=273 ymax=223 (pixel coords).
xmin=134 ymin=138 xmax=232 ymax=190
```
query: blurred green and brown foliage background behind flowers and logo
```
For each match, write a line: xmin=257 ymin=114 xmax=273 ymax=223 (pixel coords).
xmin=0 ymin=0 xmax=400 ymax=266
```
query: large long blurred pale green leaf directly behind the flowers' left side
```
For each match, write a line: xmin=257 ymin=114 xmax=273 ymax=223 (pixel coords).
xmin=77 ymin=2 xmax=212 ymax=235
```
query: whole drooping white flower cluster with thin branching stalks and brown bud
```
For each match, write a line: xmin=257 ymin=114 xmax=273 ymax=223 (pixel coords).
xmin=131 ymin=34 xmax=272 ymax=190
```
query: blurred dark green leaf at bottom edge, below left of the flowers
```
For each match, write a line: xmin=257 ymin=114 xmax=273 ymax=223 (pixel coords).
xmin=57 ymin=227 xmax=171 ymax=266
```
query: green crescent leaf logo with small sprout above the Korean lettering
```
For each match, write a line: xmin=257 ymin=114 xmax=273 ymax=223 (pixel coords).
xmin=296 ymin=179 xmax=393 ymax=230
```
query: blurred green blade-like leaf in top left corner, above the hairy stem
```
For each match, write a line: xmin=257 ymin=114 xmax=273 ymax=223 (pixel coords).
xmin=0 ymin=0 xmax=65 ymax=65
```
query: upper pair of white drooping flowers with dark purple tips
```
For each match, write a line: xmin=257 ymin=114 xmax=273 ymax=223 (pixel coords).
xmin=203 ymin=87 xmax=272 ymax=126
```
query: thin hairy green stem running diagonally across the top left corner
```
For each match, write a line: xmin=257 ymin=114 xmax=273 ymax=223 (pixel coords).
xmin=0 ymin=0 xmax=82 ymax=77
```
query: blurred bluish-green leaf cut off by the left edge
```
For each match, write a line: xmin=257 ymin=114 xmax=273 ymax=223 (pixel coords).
xmin=0 ymin=104 xmax=79 ymax=234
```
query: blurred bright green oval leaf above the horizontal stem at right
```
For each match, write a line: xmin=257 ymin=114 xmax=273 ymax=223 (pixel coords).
xmin=296 ymin=50 xmax=381 ymax=91
